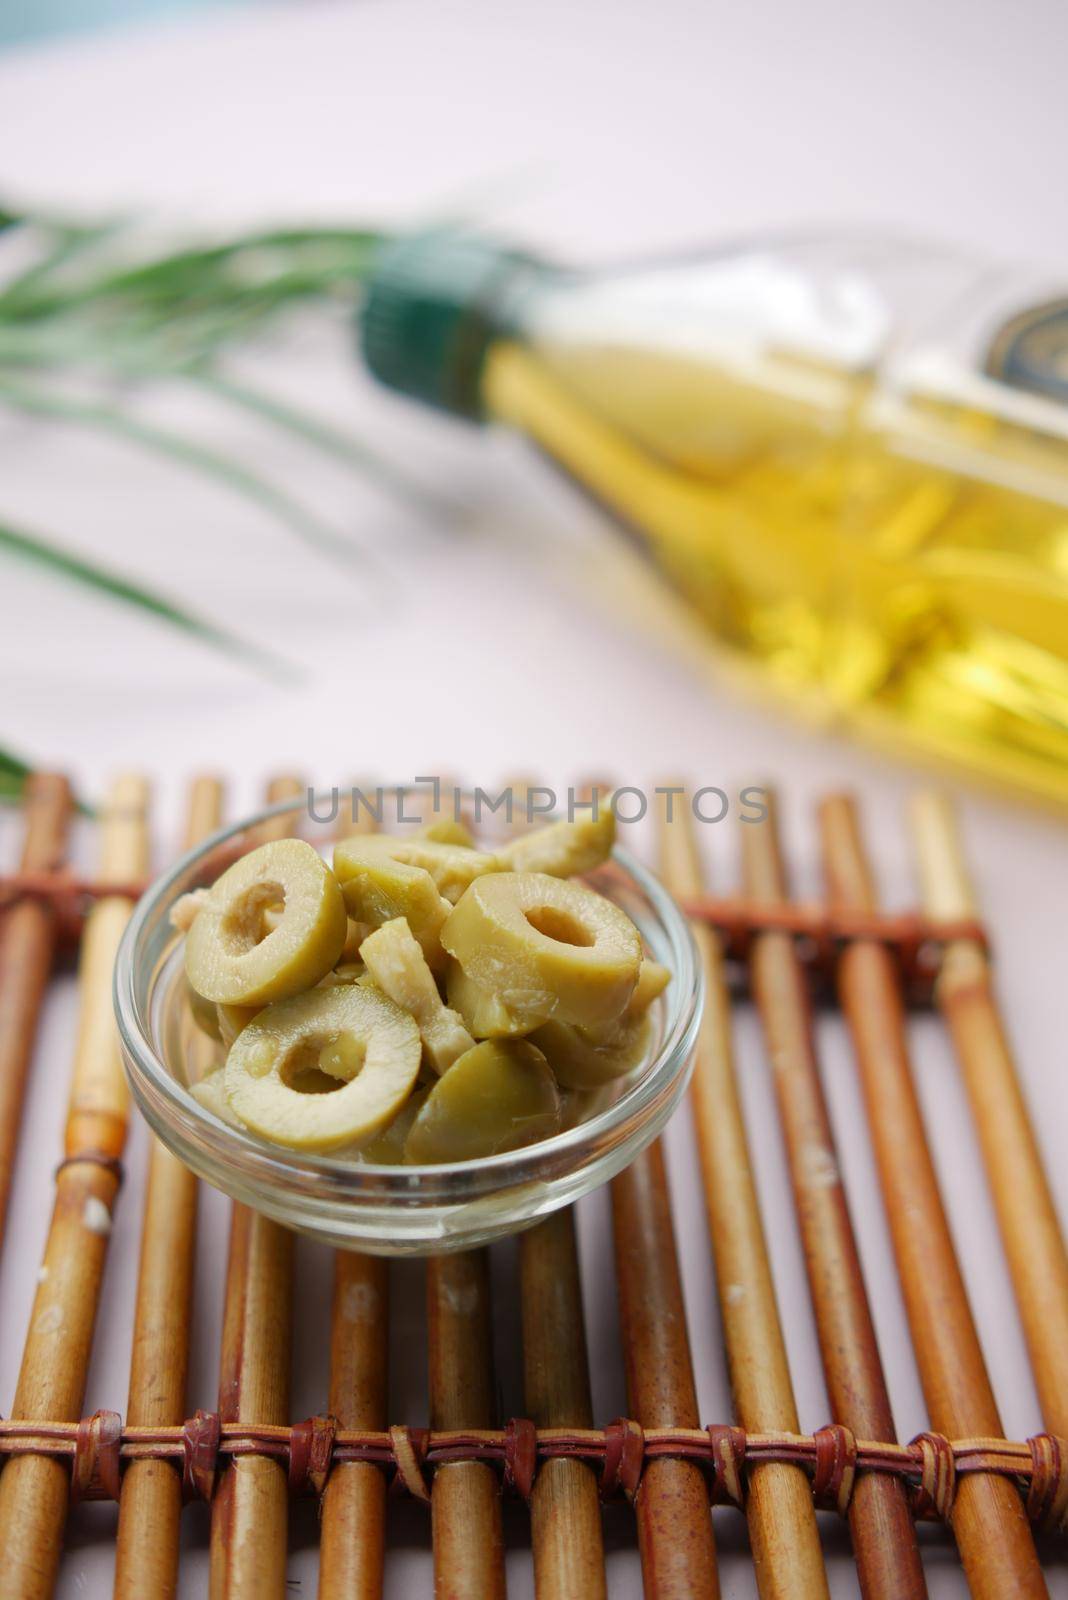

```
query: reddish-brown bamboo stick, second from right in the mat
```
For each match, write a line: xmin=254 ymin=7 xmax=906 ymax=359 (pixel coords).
xmin=820 ymin=795 xmax=1047 ymax=1600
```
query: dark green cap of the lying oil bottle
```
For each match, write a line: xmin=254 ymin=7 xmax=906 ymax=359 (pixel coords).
xmin=360 ymin=232 xmax=542 ymax=418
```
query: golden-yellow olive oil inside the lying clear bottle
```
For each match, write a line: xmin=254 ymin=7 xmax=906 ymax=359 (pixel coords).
xmin=483 ymin=342 xmax=1068 ymax=802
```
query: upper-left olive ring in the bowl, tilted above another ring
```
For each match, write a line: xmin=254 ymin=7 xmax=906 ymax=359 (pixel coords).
xmin=185 ymin=838 xmax=349 ymax=1005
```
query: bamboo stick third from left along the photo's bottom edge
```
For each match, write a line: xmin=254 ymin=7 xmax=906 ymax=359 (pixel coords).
xmin=209 ymin=778 xmax=304 ymax=1600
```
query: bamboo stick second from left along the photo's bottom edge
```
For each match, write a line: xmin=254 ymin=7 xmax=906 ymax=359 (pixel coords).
xmin=115 ymin=778 xmax=222 ymax=1600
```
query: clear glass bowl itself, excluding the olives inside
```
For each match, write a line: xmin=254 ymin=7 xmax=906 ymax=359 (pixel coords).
xmin=115 ymin=790 xmax=703 ymax=1256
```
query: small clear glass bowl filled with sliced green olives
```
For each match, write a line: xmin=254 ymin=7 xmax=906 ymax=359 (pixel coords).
xmin=115 ymin=798 xmax=702 ymax=1254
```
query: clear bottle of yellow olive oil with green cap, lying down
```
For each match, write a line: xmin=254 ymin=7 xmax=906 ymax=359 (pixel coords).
xmin=361 ymin=235 xmax=1068 ymax=806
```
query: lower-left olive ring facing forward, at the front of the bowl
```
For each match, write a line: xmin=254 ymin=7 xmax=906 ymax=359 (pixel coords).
xmin=224 ymin=982 xmax=422 ymax=1150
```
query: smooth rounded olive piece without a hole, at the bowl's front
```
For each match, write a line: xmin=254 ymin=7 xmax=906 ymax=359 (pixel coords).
xmin=404 ymin=1038 xmax=560 ymax=1165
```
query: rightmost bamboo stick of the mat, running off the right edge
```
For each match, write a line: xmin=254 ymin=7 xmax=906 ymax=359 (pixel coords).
xmin=915 ymin=795 xmax=1068 ymax=1438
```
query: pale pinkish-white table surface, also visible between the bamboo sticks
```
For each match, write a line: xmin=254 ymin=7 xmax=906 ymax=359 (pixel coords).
xmin=0 ymin=0 xmax=1068 ymax=1597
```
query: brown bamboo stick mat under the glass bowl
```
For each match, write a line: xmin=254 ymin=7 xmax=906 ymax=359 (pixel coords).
xmin=0 ymin=774 xmax=1068 ymax=1600
